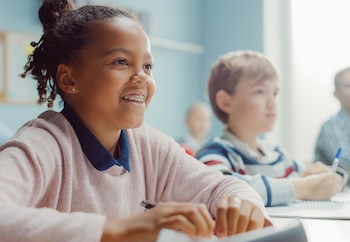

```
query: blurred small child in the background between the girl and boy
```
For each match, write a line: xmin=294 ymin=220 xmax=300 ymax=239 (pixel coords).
xmin=178 ymin=102 xmax=212 ymax=155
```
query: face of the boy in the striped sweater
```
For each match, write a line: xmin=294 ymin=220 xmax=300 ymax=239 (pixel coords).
xmin=224 ymin=78 xmax=279 ymax=135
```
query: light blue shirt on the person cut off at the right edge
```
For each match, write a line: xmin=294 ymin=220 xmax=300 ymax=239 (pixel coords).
xmin=315 ymin=109 xmax=350 ymax=170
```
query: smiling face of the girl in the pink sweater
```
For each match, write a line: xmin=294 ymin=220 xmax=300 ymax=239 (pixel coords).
xmin=70 ymin=18 xmax=155 ymax=130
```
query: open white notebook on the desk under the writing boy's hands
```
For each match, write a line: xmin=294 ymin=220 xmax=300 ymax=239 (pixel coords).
xmin=266 ymin=192 xmax=350 ymax=220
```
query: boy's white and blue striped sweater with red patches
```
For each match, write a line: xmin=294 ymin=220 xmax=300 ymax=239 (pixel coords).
xmin=196 ymin=130 xmax=305 ymax=206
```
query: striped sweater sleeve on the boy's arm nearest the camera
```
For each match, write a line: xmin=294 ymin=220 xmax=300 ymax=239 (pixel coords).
xmin=196 ymin=145 xmax=295 ymax=207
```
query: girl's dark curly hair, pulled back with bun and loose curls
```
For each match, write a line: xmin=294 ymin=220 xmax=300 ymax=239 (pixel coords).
xmin=22 ymin=0 xmax=139 ymax=108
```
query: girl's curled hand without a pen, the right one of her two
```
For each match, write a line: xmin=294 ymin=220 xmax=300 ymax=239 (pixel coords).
xmin=215 ymin=196 xmax=265 ymax=237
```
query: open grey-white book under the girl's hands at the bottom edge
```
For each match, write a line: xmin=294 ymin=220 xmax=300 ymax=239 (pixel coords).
xmin=157 ymin=219 xmax=307 ymax=242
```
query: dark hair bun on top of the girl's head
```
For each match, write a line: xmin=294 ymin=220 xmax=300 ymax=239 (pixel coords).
xmin=39 ymin=0 xmax=74 ymax=31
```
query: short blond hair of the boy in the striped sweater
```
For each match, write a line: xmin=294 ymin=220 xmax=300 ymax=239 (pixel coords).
xmin=208 ymin=50 xmax=279 ymax=124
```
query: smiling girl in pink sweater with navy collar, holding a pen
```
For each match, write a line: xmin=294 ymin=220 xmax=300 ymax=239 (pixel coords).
xmin=0 ymin=0 xmax=271 ymax=242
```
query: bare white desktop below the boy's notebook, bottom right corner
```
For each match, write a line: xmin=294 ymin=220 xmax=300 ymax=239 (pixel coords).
xmin=272 ymin=218 xmax=350 ymax=242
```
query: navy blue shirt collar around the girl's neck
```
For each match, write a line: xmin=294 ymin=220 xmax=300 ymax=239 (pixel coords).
xmin=61 ymin=103 xmax=130 ymax=172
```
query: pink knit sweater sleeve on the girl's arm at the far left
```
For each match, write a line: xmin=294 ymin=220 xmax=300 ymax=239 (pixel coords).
xmin=0 ymin=116 xmax=105 ymax=242
